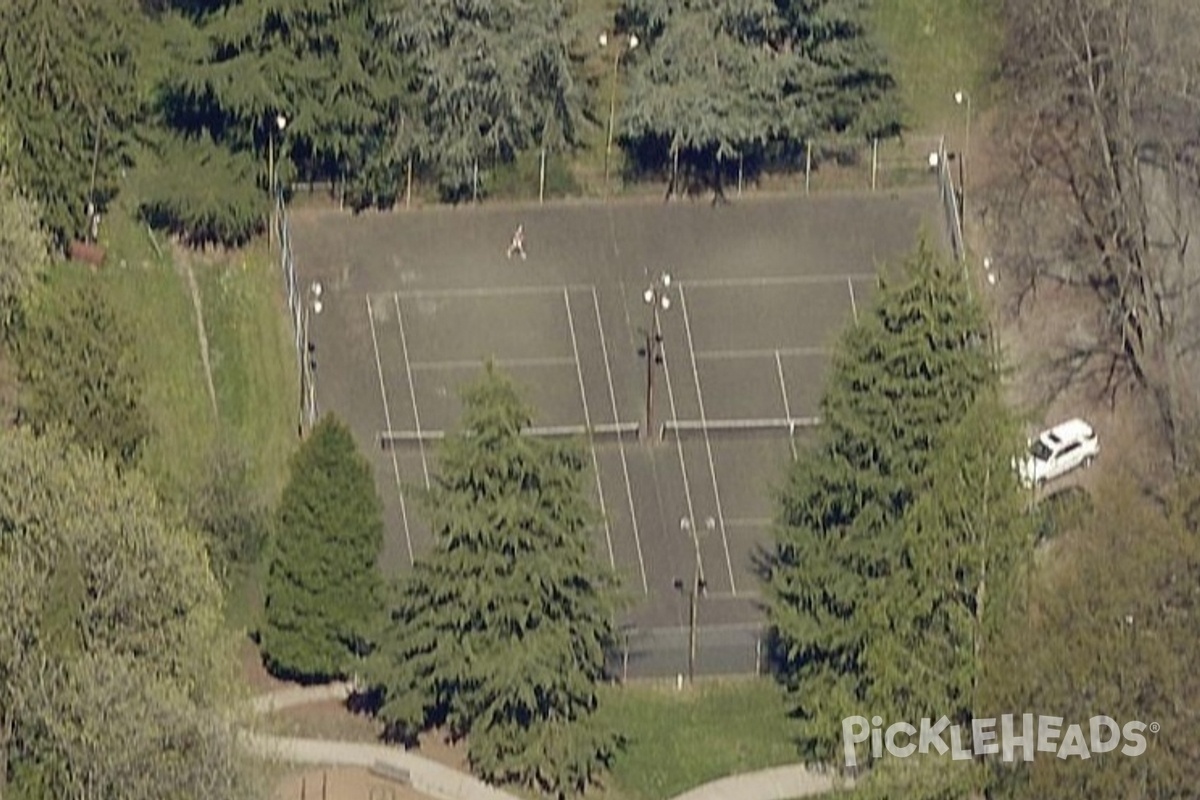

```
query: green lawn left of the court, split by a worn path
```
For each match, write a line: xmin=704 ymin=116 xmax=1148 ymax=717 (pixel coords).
xmin=91 ymin=201 xmax=299 ymax=627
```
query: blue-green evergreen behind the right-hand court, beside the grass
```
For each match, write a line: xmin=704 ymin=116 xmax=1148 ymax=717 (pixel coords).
xmin=618 ymin=0 xmax=899 ymax=192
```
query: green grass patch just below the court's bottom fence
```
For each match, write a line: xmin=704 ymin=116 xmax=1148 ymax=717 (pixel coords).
xmin=600 ymin=679 xmax=797 ymax=800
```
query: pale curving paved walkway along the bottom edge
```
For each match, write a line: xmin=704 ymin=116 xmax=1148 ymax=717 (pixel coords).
xmin=245 ymin=682 xmax=852 ymax=800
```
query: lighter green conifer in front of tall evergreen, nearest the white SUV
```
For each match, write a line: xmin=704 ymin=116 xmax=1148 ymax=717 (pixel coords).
xmin=866 ymin=386 xmax=1034 ymax=726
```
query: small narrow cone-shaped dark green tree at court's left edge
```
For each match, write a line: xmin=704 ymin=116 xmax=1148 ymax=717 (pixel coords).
xmin=262 ymin=416 xmax=383 ymax=680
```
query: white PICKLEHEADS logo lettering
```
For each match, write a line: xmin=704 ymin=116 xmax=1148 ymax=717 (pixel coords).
xmin=841 ymin=714 xmax=1159 ymax=766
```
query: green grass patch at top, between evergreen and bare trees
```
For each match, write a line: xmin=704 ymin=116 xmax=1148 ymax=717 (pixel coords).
xmin=872 ymin=0 xmax=1002 ymax=134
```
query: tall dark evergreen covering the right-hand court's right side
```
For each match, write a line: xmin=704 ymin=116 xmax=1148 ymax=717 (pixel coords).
xmin=767 ymin=241 xmax=991 ymax=759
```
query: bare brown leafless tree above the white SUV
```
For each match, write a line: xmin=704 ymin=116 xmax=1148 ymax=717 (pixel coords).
xmin=997 ymin=0 xmax=1200 ymax=469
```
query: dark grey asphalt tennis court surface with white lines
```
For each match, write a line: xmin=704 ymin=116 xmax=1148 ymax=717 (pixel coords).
xmin=294 ymin=188 xmax=937 ymax=627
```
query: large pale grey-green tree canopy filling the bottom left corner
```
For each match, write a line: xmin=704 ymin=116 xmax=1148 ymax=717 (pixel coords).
xmin=0 ymin=429 xmax=254 ymax=800
